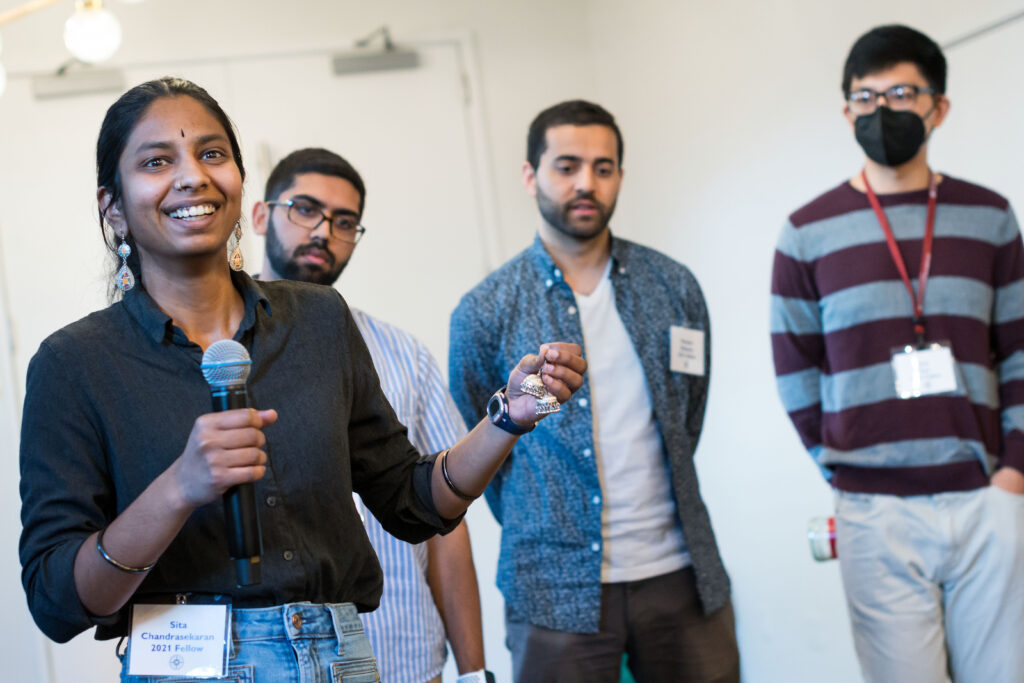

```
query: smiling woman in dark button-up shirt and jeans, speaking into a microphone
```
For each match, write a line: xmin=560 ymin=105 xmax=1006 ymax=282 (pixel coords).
xmin=20 ymin=79 xmax=586 ymax=683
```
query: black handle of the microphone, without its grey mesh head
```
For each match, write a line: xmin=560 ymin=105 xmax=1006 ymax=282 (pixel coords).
xmin=212 ymin=384 xmax=263 ymax=588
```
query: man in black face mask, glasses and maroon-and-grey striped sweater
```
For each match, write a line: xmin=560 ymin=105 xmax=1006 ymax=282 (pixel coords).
xmin=771 ymin=26 xmax=1024 ymax=683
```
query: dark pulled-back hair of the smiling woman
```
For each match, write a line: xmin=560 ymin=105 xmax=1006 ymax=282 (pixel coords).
xmin=96 ymin=76 xmax=246 ymax=300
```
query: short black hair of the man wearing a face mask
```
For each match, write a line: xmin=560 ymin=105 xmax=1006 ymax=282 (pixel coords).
xmin=843 ymin=25 xmax=946 ymax=96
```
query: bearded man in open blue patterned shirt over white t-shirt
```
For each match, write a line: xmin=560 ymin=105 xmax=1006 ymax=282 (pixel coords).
xmin=449 ymin=100 xmax=739 ymax=683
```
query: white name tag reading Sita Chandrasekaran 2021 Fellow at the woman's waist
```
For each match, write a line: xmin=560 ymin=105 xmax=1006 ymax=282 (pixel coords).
xmin=128 ymin=604 xmax=230 ymax=678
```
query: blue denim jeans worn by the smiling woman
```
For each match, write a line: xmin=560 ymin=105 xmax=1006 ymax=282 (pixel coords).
xmin=121 ymin=602 xmax=380 ymax=683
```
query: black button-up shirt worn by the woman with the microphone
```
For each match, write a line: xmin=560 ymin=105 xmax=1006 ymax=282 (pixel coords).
xmin=20 ymin=273 xmax=453 ymax=642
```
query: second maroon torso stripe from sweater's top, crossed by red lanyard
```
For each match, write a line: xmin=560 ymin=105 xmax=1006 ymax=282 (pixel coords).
xmin=813 ymin=239 xmax=996 ymax=302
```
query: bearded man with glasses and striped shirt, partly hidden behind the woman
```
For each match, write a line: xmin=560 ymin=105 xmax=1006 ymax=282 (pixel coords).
xmin=253 ymin=148 xmax=495 ymax=683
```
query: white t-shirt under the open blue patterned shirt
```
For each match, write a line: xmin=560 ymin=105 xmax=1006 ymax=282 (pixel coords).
xmin=575 ymin=259 xmax=690 ymax=583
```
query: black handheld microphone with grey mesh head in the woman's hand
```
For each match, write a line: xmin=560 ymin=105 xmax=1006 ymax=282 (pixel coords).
xmin=202 ymin=339 xmax=263 ymax=588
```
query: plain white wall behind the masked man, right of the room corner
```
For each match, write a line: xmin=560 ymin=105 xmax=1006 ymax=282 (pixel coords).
xmin=589 ymin=0 xmax=1024 ymax=683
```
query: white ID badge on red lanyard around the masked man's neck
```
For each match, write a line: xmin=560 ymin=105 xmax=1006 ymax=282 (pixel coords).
xmin=860 ymin=171 xmax=956 ymax=398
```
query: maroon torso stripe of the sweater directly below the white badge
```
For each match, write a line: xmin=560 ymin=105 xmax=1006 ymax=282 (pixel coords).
xmin=821 ymin=396 xmax=1000 ymax=453
